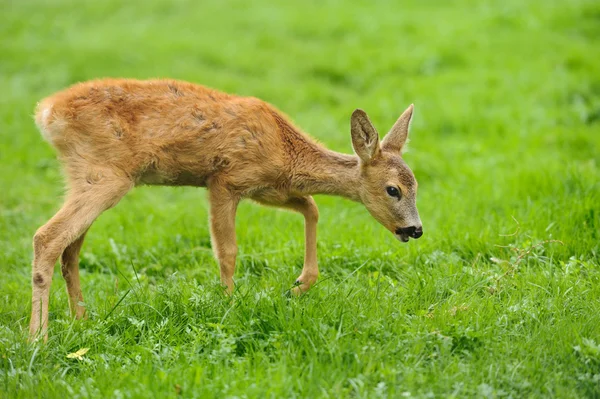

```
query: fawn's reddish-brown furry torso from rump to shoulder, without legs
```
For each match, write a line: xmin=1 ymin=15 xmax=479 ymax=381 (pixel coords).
xmin=36 ymin=79 xmax=286 ymax=189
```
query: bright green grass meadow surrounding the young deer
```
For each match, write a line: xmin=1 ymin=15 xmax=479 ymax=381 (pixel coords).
xmin=0 ymin=0 xmax=600 ymax=398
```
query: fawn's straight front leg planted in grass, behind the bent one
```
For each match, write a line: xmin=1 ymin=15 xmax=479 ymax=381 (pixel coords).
xmin=209 ymin=187 xmax=239 ymax=294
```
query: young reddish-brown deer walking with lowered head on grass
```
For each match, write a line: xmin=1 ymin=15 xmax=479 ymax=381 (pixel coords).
xmin=29 ymin=78 xmax=423 ymax=341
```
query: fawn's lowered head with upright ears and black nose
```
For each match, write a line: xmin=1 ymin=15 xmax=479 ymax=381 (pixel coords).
xmin=351 ymin=105 xmax=423 ymax=242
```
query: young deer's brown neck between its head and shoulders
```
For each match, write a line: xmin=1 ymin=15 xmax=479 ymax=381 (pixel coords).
xmin=291 ymin=140 xmax=360 ymax=201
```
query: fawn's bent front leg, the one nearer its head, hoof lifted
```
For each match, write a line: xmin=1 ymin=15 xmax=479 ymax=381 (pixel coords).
xmin=284 ymin=196 xmax=319 ymax=294
